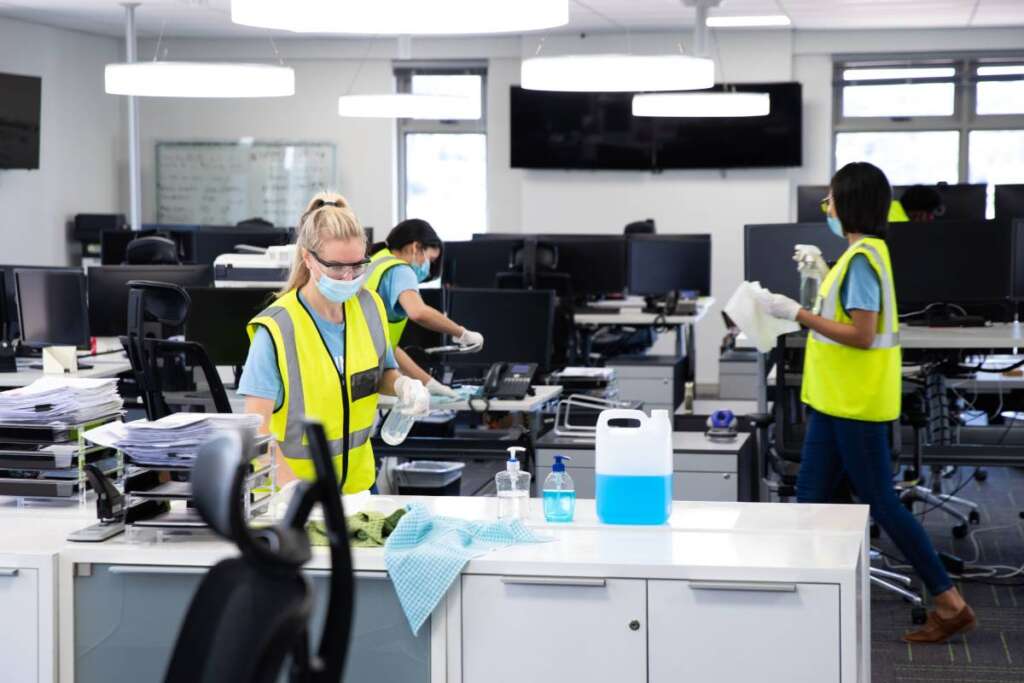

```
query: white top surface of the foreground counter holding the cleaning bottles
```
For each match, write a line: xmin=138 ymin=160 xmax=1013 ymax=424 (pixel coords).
xmin=0 ymin=494 xmax=867 ymax=582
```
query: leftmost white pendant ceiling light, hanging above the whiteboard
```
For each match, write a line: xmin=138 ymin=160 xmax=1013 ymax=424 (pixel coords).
xmin=104 ymin=61 xmax=295 ymax=97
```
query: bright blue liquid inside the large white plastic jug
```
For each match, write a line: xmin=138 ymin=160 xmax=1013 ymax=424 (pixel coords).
xmin=597 ymin=474 xmax=672 ymax=524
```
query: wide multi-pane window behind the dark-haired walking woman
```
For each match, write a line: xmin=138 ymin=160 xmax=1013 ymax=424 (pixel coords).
xmin=834 ymin=54 xmax=1024 ymax=217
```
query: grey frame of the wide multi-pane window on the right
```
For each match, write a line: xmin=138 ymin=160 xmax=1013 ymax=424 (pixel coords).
xmin=829 ymin=51 xmax=1024 ymax=182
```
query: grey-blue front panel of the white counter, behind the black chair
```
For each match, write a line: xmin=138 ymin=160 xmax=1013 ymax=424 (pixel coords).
xmin=73 ymin=564 xmax=430 ymax=683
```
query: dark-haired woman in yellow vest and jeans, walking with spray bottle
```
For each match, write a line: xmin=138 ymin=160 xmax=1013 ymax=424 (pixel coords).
xmin=762 ymin=163 xmax=977 ymax=643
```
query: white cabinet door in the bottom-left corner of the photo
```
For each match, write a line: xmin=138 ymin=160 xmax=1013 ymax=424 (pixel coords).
xmin=0 ymin=566 xmax=40 ymax=683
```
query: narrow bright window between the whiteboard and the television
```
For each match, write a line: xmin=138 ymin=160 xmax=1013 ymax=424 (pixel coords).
xmin=395 ymin=62 xmax=487 ymax=241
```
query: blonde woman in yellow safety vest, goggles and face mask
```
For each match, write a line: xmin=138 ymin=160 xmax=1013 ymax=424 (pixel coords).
xmin=239 ymin=194 xmax=430 ymax=494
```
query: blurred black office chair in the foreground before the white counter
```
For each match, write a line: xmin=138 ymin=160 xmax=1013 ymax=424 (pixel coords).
xmin=164 ymin=422 xmax=355 ymax=683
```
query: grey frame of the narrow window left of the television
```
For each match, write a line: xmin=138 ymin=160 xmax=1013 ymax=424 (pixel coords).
xmin=393 ymin=59 xmax=487 ymax=221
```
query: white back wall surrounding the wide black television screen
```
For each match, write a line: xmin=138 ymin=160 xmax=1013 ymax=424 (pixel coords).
xmin=125 ymin=29 xmax=1024 ymax=385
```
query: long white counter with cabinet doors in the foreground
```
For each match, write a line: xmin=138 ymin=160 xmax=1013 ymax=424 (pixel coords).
xmin=0 ymin=492 xmax=870 ymax=683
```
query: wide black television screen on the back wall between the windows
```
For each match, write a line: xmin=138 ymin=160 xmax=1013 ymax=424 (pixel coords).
xmin=511 ymin=83 xmax=803 ymax=170
